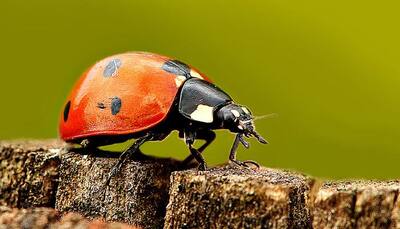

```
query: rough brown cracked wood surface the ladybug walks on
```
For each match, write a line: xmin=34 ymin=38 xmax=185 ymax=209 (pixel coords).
xmin=0 ymin=140 xmax=400 ymax=229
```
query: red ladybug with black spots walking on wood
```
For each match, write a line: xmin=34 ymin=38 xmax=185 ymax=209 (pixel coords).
xmin=59 ymin=52 xmax=267 ymax=177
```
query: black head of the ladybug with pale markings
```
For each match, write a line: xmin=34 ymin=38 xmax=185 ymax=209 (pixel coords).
xmin=216 ymin=103 xmax=267 ymax=144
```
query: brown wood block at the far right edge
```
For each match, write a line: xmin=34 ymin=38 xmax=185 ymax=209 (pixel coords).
xmin=313 ymin=181 xmax=400 ymax=228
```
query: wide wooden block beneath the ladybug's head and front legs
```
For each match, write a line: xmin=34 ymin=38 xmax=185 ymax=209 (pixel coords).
xmin=164 ymin=166 xmax=313 ymax=228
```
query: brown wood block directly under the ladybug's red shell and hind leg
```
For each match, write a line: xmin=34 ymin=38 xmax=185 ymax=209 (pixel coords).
xmin=56 ymin=149 xmax=191 ymax=228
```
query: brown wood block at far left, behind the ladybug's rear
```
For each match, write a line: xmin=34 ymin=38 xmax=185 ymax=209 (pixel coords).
xmin=0 ymin=140 xmax=63 ymax=208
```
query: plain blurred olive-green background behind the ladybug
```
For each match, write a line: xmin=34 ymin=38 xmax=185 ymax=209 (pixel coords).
xmin=0 ymin=0 xmax=400 ymax=178
